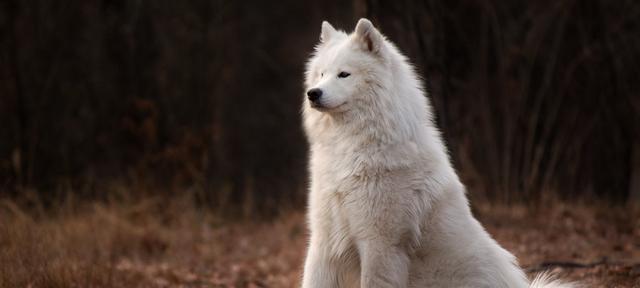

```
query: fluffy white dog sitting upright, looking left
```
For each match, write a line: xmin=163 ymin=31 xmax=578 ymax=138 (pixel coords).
xmin=302 ymin=19 xmax=572 ymax=288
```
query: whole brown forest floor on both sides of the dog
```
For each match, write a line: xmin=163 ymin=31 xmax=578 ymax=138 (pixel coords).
xmin=0 ymin=199 xmax=640 ymax=287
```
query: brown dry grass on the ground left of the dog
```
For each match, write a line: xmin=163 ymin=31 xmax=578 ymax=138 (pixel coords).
xmin=0 ymin=197 xmax=304 ymax=287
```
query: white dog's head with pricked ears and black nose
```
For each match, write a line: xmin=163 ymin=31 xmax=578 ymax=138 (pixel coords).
xmin=305 ymin=19 xmax=388 ymax=113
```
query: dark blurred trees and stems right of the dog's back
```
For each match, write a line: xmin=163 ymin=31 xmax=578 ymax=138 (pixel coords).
xmin=361 ymin=0 xmax=640 ymax=201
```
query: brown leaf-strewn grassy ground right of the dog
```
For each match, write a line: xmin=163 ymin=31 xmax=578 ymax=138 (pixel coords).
xmin=475 ymin=202 xmax=640 ymax=287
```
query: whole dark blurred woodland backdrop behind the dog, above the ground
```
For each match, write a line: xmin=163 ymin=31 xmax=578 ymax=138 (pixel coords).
xmin=0 ymin=0 xmax=640 ymax=213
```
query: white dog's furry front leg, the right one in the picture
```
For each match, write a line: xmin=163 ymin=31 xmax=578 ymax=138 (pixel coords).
xmin=359 ymin=239 xmax=409 ymax=288
